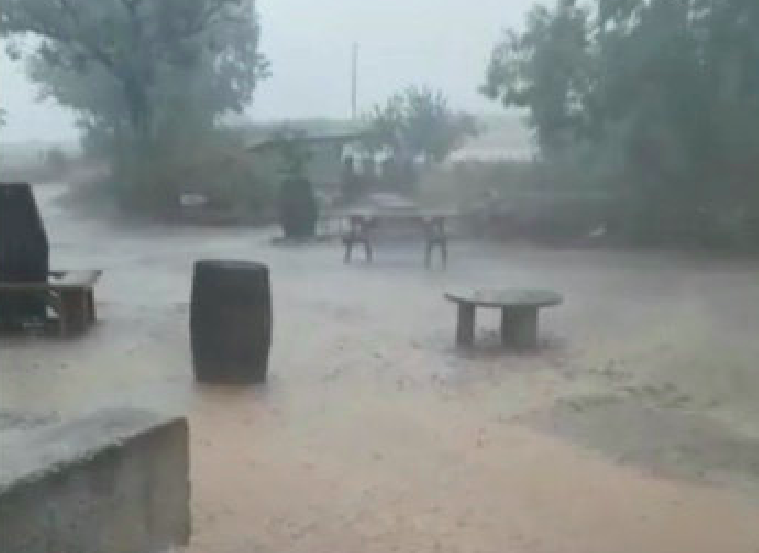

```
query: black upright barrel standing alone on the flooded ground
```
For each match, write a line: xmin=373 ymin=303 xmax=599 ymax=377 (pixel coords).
xmin=190 ymin=260 xmax=272 ymax=383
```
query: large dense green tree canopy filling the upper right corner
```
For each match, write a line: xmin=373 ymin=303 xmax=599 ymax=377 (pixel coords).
xmin=481 ymin=0 xmax=759 ymax=244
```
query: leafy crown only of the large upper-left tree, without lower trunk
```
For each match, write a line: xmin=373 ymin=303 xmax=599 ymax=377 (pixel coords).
xmin=0 ymin=0 xmax=268 ymax=143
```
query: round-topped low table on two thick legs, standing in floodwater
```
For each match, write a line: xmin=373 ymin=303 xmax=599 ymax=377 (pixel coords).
xmin=445 ymin=289 xmax=563 ymax=349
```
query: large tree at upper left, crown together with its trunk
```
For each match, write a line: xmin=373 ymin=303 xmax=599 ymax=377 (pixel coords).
xmin=0 ymin=0 xmax=268 ymax=212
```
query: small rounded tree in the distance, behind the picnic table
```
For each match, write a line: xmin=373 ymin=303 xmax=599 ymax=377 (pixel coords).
xmin=366 ymin=87 xmax=477 ymax=162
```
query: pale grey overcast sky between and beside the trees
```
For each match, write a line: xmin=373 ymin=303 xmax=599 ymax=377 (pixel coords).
xmin=0 ymin=0 xmax=535 ymax=141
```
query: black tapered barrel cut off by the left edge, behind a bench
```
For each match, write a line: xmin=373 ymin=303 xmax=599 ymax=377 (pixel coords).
xmin=0 ymin=183 xmax=50 ymax=327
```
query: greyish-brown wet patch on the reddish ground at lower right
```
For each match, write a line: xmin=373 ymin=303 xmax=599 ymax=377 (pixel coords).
xmin=536 ymin=395 xmax=759 ymax=497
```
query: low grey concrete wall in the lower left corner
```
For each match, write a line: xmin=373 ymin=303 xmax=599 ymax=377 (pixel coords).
xmin=0 ymin=409 xmax=190 ymax=553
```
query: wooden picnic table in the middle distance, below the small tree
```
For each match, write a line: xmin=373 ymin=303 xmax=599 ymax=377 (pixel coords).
xmin=343 ymin=214 xmax=448 ymax=269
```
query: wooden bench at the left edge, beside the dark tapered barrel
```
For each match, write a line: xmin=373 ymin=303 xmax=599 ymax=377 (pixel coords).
xmin=0 ymin=270 xmax=102 ymax=336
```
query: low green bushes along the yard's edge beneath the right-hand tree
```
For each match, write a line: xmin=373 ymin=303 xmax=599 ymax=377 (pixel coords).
xmin=421 ymin=155 xmax=759 ymax=250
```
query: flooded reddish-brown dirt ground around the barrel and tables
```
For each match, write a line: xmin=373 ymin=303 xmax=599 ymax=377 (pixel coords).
xmin=0 ymin=186 xmax=759 ymax=553
